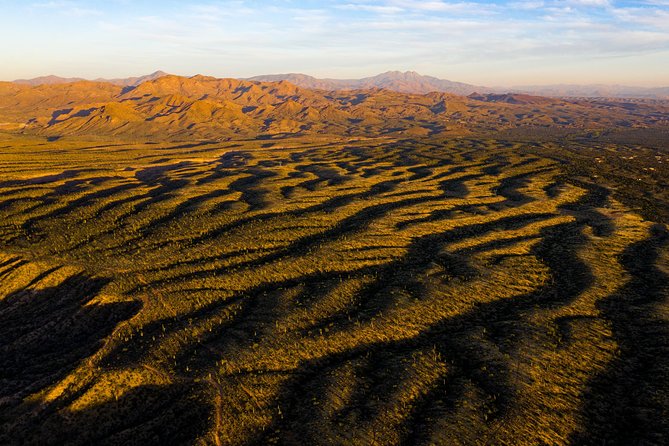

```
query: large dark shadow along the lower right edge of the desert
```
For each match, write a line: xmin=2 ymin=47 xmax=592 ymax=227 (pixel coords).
xmin=572 ymin=224 xmax=669 ymax=445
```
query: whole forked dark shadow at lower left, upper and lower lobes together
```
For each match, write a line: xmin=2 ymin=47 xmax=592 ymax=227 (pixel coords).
xmin=0 ymin=274 xmax=209 ymax=446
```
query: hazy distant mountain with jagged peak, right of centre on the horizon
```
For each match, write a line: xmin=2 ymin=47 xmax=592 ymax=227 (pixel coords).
xmin=249 ymin=71 xmax=492 ymax=95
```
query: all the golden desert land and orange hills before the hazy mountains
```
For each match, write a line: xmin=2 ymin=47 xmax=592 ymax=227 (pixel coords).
xmin=0 ymin=76 xmax=669 ymax=445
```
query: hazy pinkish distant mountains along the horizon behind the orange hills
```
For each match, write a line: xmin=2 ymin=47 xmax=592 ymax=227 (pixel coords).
xmin=14 ymin=71 xmax=669 ymax=99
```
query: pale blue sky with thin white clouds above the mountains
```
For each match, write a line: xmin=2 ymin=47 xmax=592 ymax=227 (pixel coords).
xmin=0 ymin=0 xmax=669 ymax=86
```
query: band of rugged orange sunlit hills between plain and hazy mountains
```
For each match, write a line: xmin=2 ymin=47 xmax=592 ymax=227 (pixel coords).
xmin=0 ymin=75 xmax=669 ymax=140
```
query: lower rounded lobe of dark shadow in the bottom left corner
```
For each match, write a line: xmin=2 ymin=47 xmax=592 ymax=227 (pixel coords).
xmin=0 ymin=384 xmax=210 ymax=446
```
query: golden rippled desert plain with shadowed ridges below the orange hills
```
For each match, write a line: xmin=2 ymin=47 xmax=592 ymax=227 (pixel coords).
xmin=0 ymin=134 xmax=669 ymax=445
